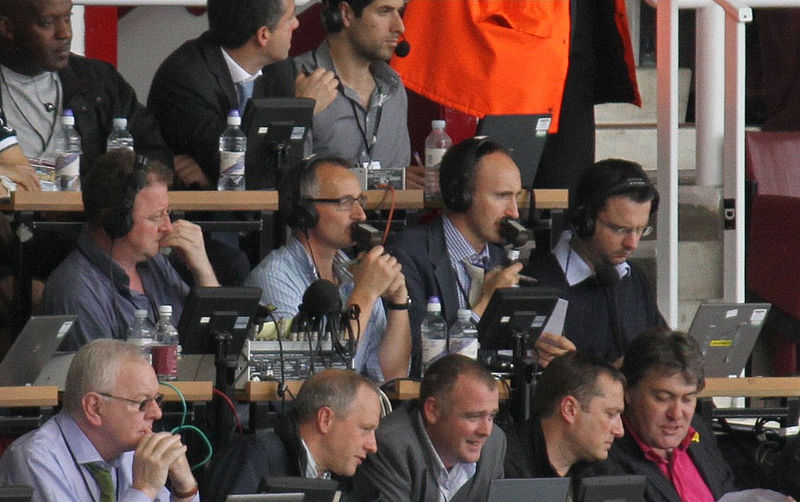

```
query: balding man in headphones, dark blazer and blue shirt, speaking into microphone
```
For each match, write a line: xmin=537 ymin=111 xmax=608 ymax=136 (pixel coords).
xmin=393 ymin=137 xmax=522 ymax=375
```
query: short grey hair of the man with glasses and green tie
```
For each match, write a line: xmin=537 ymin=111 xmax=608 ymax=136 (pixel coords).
xmin=64 ymin=338 xmax=148 ymax=416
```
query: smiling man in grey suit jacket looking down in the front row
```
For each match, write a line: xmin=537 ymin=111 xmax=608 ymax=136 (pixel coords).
xmin=353 ymin=354 xmax=506 ymax=502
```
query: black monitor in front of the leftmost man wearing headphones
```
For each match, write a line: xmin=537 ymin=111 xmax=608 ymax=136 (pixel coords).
xmin=178 ymin=287 xmax=261 ymax=355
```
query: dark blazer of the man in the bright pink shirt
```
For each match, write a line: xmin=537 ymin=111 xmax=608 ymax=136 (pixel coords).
xmin=609 ymin=416 xmax=736 ymax=502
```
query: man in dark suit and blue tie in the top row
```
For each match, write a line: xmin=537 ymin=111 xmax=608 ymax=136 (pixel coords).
xmin=147 ymin=0 xmax=335 ymax=188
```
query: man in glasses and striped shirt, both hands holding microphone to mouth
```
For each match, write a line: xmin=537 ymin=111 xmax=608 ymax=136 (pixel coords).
xmin=245 ymin=156 xmax=411 ymax=382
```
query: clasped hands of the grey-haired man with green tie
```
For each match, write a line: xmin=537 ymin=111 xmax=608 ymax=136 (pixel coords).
xmin=132 ymin=432 xmax=194 ymax=500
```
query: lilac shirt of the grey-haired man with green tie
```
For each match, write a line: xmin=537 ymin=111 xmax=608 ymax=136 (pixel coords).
xmin=0 ymin=411 xmax=200 ymax=502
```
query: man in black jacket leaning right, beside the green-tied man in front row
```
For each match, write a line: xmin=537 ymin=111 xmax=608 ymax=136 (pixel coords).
xmin=204 ymin=369 xmax=381 ymax=502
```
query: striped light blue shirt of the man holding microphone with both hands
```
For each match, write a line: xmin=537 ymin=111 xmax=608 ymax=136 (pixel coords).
xmin=245 ymin=235 xmax=386 ymax=382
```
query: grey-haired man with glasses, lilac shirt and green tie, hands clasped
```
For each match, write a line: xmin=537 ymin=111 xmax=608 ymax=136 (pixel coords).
xmin=0 ymin=340 xmax=199 ymax=502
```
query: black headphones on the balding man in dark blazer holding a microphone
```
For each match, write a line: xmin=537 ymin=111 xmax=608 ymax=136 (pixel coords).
xmin=439 ymin=136 xmax=506 ymax=213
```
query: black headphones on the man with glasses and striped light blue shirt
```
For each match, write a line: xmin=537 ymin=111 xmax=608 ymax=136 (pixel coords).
xmin=278 ymin=155 xmax=326 ymax=232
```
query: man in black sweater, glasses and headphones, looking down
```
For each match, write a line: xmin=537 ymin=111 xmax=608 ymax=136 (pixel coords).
xmin=526 ymin=159 xmax=664 ymax=366
